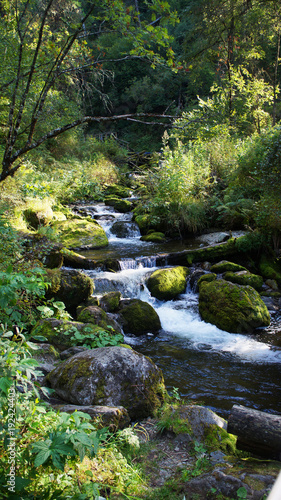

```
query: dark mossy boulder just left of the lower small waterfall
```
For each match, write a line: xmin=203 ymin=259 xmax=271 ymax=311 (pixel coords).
xmin=45 ymin=269 xmax=94 ymax=312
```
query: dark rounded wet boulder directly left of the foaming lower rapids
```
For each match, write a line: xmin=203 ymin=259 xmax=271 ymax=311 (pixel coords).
xmin=120 ymin=299 xmax=161 ymax=335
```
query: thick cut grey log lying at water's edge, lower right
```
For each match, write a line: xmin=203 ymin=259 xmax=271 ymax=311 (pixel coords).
xmin=227 ymin=405 xmax=281 ymax=461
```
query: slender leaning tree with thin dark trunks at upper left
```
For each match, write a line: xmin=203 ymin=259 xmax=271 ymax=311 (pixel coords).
xmin=0 ymin=0 xmax=176 ymax=182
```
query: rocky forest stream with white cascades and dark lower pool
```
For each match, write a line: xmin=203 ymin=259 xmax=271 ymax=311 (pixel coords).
xmin=72 ymin=203 xmax=281 ymax=418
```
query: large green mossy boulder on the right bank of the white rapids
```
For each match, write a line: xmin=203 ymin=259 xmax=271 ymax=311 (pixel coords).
xmin=199 ymin=279 xmax=270 ymax=333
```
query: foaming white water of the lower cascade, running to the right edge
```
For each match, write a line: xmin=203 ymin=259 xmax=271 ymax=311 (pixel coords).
xmin=87 ymin=266 xmax=281 ymax=363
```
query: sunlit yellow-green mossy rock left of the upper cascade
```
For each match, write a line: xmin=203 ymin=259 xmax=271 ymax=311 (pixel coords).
xmin=52 ymin=217 xmax=108 ymax=250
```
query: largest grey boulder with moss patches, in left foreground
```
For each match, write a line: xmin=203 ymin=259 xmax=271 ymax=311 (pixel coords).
xmin=46 ymin=346 xmax=166 ymax=419
